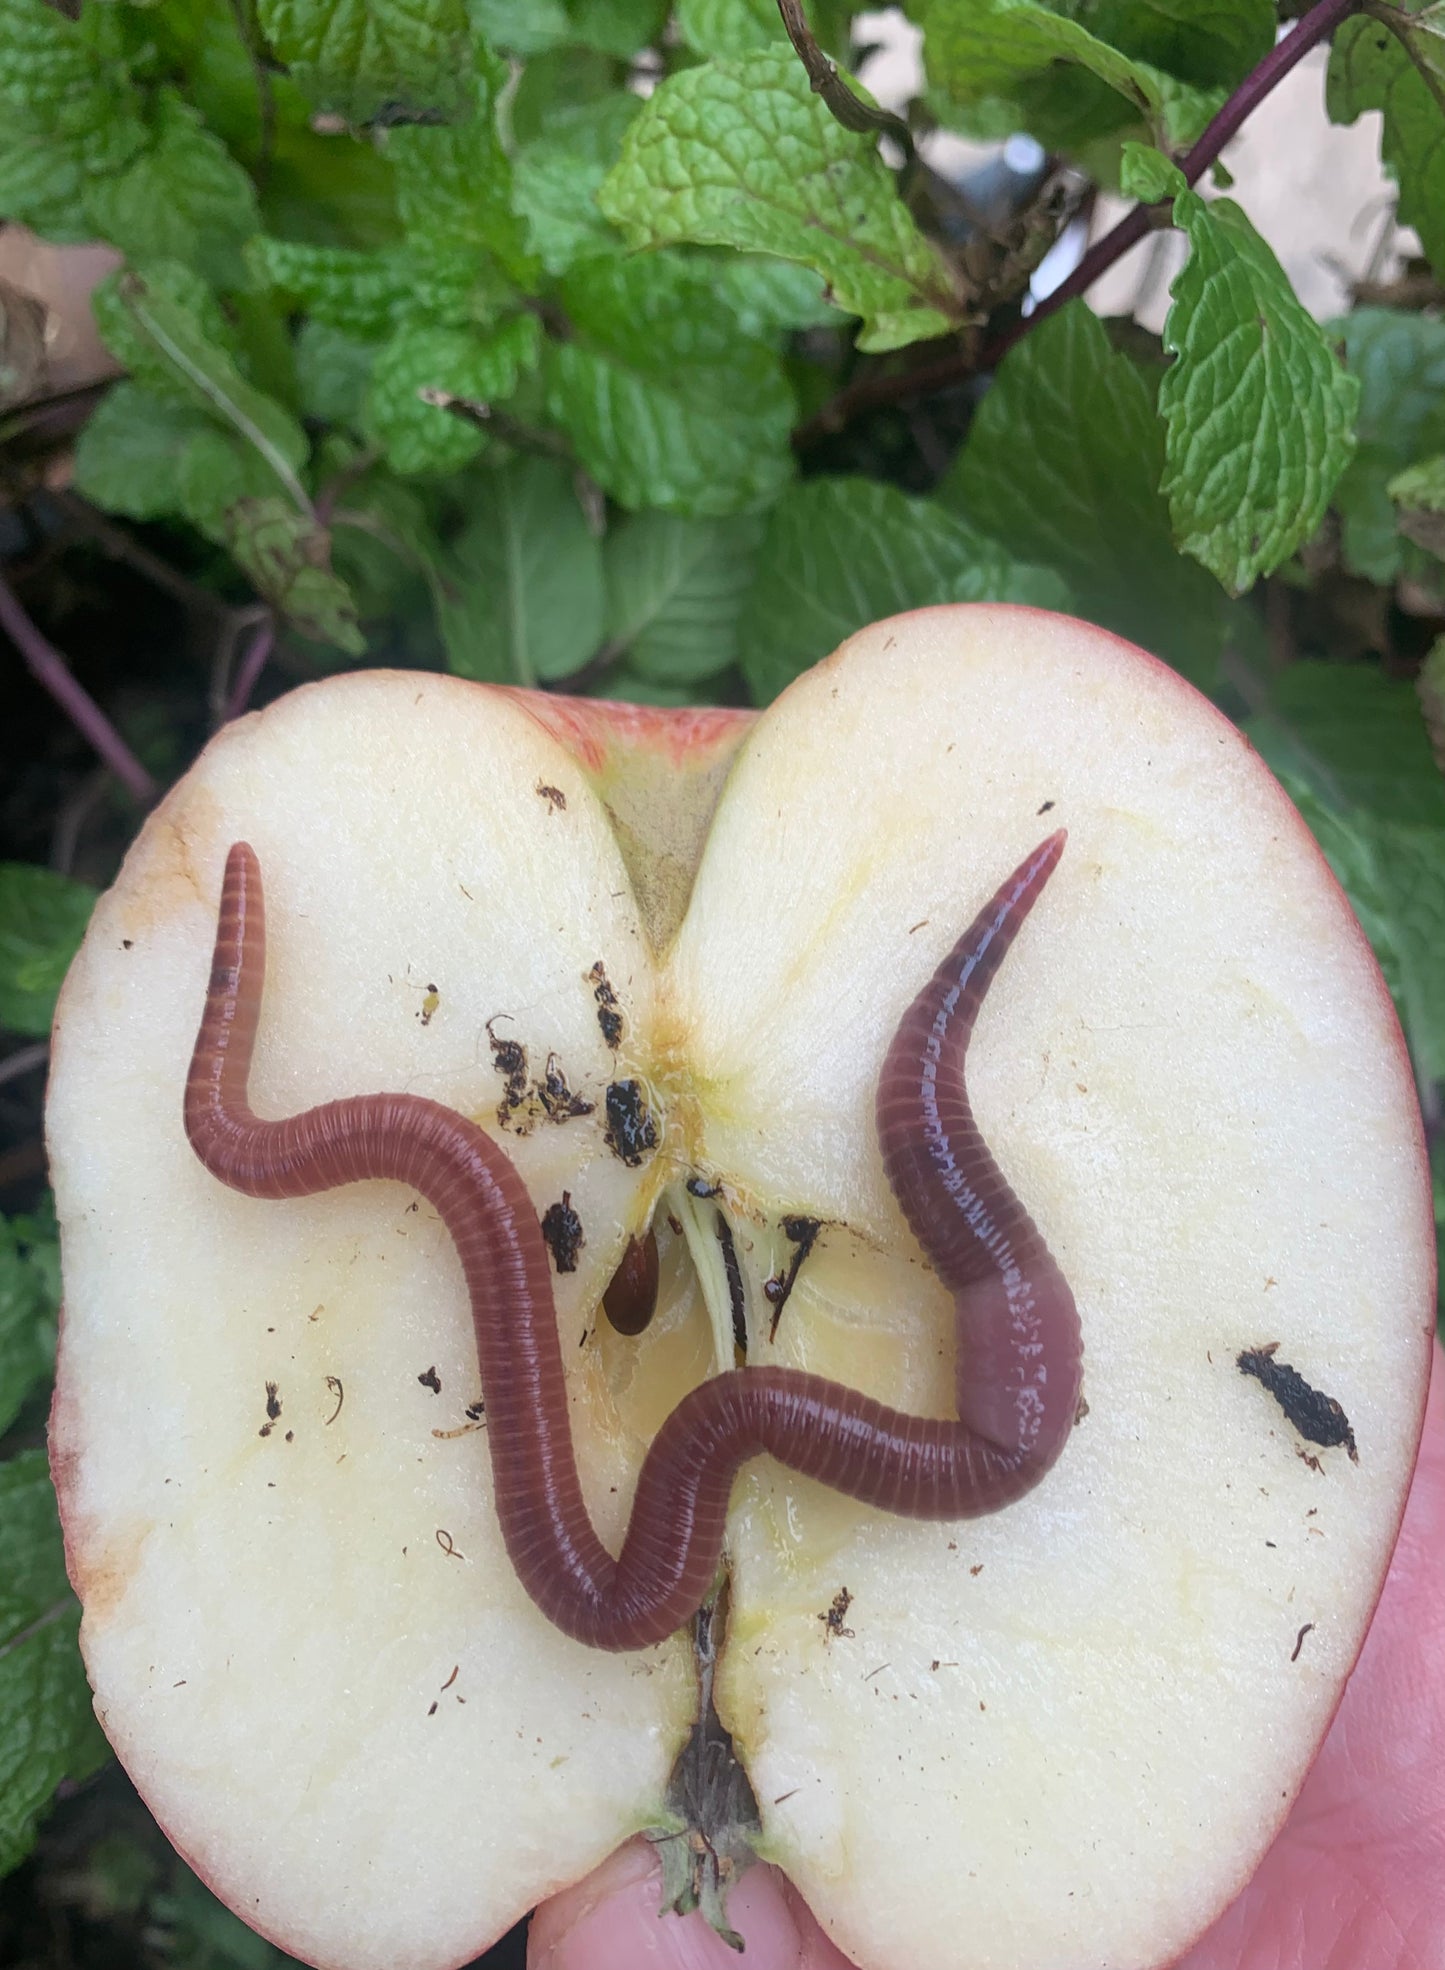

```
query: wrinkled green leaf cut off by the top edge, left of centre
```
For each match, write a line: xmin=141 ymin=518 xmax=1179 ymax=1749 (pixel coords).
xmin=256 ymin=0 xmax=472 ymax=122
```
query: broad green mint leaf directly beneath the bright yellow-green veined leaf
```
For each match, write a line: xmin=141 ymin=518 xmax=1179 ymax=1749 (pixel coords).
xmin=543 ymin=254 xmax=793 ymax=518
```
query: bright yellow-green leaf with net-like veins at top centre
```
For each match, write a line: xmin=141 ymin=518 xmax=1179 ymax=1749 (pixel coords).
xmin=598 ymin=47 xmax=965 ymax=351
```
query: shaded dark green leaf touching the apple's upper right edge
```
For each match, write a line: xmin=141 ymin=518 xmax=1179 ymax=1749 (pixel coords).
xmin=1250 ymin=662 xmax=1445 ymax=1080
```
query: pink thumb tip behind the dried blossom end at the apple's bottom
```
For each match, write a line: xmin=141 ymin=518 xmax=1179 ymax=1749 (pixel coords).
xmin=528 ymin=1840 xmax=850 ymax=1970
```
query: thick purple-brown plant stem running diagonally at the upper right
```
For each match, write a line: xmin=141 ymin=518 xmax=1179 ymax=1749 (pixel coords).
xmin=793 ymin=0 xmax=1364 ymax=449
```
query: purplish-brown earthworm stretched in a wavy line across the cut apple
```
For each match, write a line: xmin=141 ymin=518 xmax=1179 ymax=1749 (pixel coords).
xmin=185 ymin=833 xmax=1079 ymax=1649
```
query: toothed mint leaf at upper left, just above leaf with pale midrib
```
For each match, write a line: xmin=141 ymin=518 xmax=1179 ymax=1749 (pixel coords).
xmin=87 ymin=89 xmax=260 ymax=288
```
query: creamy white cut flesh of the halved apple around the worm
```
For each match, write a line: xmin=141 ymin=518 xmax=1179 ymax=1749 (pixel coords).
xmin=49 ymin=607 xmax=1433 ymax=1970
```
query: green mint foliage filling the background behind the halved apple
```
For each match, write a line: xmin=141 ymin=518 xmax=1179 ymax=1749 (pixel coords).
xmin=0 ymin=0 xmax=1445 ymax=1960
